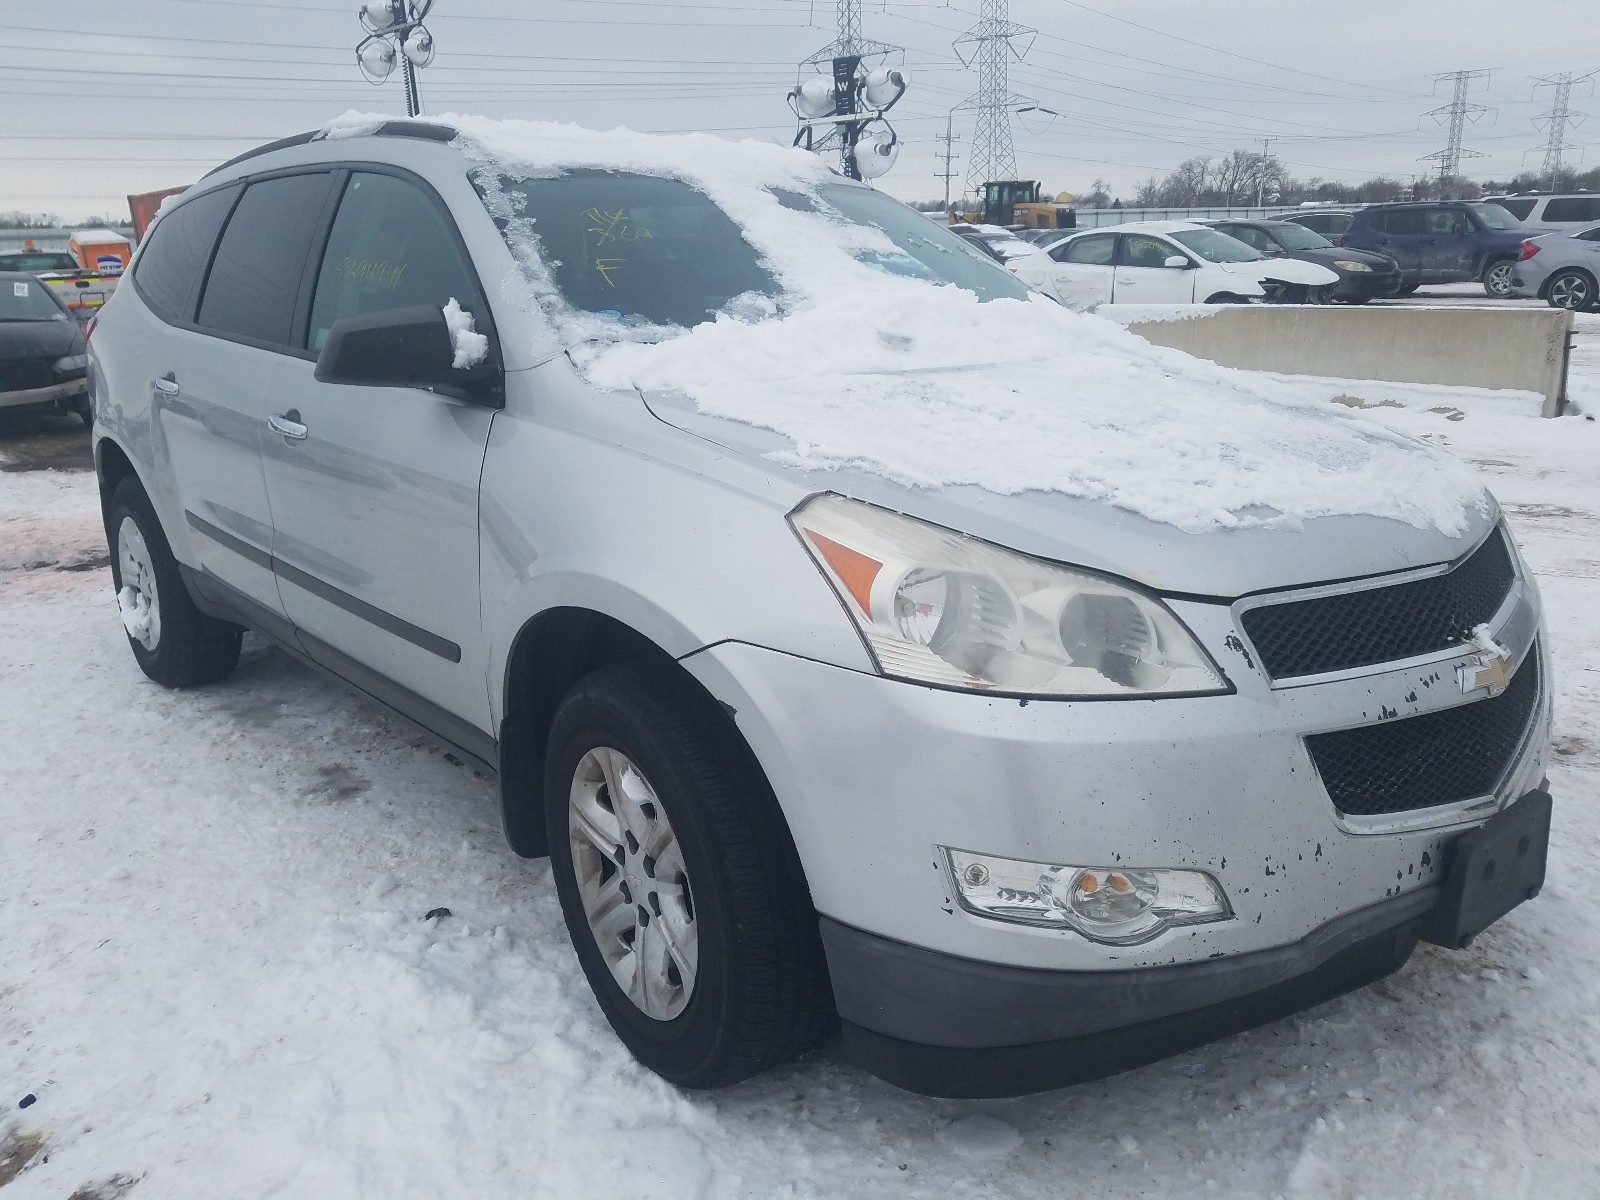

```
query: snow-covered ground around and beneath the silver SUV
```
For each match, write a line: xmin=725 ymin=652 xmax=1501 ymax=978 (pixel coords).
xmin=0 ymin=307 xmax=1600 ymax=1200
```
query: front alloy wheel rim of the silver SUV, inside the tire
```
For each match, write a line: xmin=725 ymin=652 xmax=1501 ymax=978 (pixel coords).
xmin=568 ymin=746 xmax=699 ymax=1021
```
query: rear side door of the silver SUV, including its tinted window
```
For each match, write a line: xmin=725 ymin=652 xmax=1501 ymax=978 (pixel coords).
xmin=151 ymin=170 xmax=331 ymax=616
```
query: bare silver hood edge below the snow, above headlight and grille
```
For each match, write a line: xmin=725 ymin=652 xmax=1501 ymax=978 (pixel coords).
xmin=645 ymin=392 xmax=1499 ymax=600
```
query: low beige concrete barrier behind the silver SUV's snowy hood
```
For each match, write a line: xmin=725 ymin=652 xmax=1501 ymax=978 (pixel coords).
xmin=1094 ymin=304 xmax=1573 ymax=416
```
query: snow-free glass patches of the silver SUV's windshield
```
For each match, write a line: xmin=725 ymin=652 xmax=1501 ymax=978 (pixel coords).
xmin=480 ymin=170 xmax=1027 ymax=328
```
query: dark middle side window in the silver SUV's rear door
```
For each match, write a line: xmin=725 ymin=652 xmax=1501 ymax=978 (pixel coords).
xmin=200 ymin=173 xmax=331 ymax=346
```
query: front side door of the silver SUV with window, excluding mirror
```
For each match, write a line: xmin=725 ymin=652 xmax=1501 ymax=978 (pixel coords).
xmin=262 ymin=166 xmax=499 ymax=749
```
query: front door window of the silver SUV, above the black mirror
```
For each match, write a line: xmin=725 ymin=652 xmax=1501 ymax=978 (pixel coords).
xmin=306 ymin=171 xmax=483 ymax=350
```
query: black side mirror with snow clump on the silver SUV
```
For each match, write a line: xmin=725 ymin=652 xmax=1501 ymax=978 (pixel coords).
xmin=315 ymin=304 xmax=499 ymax=405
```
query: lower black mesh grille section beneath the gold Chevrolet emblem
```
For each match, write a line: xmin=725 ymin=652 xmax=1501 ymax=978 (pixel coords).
xmin=1306 ymin=645 xmax=1539 ymax=816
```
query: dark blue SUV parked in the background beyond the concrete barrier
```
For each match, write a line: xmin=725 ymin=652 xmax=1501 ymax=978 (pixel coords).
xmin=1339 ymin=202 xmax=1539 ymax=298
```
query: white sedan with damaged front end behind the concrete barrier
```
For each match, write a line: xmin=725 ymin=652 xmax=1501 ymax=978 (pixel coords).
xmin=1008 ymin=221 xmax=1339 ymax=309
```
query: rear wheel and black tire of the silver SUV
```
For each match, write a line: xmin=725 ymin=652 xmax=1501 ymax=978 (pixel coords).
xmin=106 ymin=475 xmax=245 ymax=688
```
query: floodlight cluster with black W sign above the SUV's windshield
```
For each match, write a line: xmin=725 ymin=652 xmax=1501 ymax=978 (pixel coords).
xmin=789 ymin=0 xmax=906 ymax=179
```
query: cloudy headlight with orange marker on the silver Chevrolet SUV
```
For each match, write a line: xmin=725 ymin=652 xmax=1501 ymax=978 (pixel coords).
xmin=789 ymin=496 xmax=1230 ymax=699
